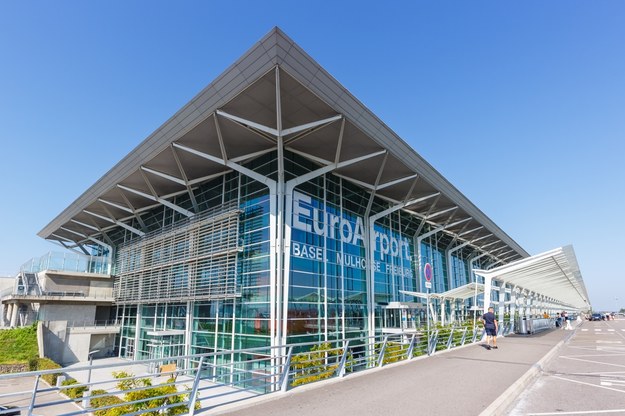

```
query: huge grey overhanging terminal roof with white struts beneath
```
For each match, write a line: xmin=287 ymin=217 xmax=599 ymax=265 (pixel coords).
xmin=39 ymin=28 xmax=528 ymax=264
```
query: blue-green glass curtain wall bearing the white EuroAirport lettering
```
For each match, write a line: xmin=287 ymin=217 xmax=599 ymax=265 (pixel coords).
xmin=109 ymin=152 xmax=482 ymax=359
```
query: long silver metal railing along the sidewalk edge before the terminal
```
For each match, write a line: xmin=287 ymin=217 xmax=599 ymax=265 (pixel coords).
xmin=0 ymin=327 xmax=482 ymax=415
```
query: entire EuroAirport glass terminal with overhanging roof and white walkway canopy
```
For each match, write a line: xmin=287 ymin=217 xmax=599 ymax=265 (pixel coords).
xmin=39 ymin=28 xmax=589 ymax=359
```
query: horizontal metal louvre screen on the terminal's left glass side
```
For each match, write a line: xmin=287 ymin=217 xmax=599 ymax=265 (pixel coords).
xmin=115 ymin=209 xmax=240 ymax=304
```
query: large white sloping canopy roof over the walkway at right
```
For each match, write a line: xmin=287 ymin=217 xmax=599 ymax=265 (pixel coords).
xmin=474 ymin=245 xmax=590 ymax=310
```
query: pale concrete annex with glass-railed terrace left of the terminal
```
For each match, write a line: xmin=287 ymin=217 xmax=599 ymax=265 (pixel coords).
xmin=0 ymin=253 xmax=120 ymax=364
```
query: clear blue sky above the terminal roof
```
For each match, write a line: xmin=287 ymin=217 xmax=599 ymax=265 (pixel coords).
xmin=0 ymin=0 xmax=625 ymax=309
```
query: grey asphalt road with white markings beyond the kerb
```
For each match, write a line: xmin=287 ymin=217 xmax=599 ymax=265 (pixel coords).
xmin=510 ymin=319 xmax=625 ymax=416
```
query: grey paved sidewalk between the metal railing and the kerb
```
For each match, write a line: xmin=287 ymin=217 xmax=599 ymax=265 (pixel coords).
xmin=209 ymin=329 xmax=574 ymax=416
